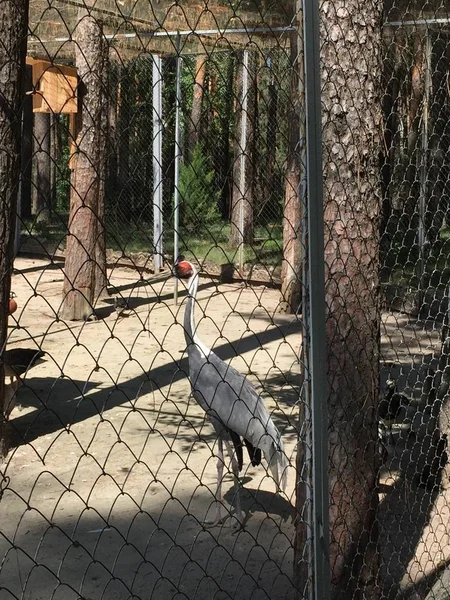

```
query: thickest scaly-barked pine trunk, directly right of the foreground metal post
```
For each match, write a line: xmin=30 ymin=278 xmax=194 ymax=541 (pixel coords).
xmin=321 ymin=0 xmax=382 ymax=600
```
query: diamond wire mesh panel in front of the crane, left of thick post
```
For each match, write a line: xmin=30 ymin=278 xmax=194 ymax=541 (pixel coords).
xmin=0 ymin=0 xmax=301 ymax=600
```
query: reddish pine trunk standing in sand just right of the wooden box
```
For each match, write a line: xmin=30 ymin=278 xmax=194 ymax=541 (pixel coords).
xmin=61 ymin=9 xmax=108 ymax=321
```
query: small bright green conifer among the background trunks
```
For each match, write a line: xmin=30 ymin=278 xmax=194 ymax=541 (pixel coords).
xmin=178 ymin=143 xmax=220 ymax=233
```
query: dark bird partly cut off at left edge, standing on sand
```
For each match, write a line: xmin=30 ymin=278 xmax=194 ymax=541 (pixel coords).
xmin=2 ymin=348 xmax=46 ymax=418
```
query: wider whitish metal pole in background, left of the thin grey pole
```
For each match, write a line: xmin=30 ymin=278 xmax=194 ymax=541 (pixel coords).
xmin=153 ymin=55 xmax=163 ymax=273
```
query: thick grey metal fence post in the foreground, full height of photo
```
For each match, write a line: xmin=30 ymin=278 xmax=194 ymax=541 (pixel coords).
xmin=303 ymin=0 xmax=330 ymax=600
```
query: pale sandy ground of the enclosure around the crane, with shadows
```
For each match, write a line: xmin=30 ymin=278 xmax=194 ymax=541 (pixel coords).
xmin=0 ymin=258 xmax=301 ymax=600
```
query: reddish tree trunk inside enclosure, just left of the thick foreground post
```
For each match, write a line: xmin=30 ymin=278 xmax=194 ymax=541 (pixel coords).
xmin=279 ymin=35 xmax=306 ymax=313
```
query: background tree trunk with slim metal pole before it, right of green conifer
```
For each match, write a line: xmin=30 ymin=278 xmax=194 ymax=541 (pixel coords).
xmin=230 ymin=51 xmax=257 ymax=246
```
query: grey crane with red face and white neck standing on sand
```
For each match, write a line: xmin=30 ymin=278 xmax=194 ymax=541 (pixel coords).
xmin=174 ymin=256 xmax=288 ymax=526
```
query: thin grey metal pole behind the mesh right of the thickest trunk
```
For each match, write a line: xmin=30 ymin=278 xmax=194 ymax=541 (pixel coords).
xmin=417 ymin=29 xmax=432 ymax=298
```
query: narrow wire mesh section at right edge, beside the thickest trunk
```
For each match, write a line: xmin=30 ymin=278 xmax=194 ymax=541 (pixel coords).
xmin=380 ymin=3 xmax=450 ymax=598
